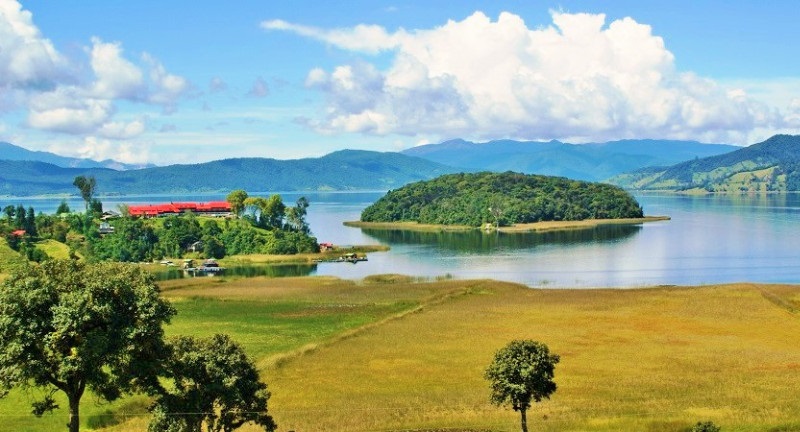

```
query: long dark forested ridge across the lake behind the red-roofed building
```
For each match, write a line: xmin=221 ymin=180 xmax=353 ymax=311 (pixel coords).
xmin=0 ymin=150 xmax=457 ymax=196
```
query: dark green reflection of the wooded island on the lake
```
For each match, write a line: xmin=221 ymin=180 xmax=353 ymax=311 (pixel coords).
xmin=361 ymin=225 xmax=642 ymax=254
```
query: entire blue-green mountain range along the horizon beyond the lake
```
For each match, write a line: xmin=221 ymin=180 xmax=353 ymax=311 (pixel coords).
xmin=0 ymin=135 xmax=800 ymax=196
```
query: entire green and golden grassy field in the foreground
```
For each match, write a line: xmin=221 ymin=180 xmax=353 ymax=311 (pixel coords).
xmin=0 ymin=276 xmax=800 ymax=432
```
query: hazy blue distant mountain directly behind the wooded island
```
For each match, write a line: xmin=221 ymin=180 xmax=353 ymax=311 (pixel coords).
xmin=402 ymin=139 xmax=740 ymax=181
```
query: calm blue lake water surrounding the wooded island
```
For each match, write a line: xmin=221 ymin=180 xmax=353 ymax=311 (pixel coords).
xmin=0 ymin=192 xmax=800 ymax=288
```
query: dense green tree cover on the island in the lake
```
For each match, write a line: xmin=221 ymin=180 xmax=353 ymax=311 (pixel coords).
xmin=361 ymin=172 xmax=642 ymax=226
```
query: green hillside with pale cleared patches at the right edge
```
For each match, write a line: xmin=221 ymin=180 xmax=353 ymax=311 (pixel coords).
xmin=610 ymin=135 xmax=800 ymax=192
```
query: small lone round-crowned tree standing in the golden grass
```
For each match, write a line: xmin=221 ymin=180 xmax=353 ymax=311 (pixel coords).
xmin=484 ymin=340 xmax=560 ymax=432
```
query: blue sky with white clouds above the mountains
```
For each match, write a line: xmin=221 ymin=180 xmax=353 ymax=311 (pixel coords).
xmin=0 ymin=0 xmax=800 ymax=165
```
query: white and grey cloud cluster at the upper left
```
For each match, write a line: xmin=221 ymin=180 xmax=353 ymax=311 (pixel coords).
xmin=0 ymin=0 xmax=189 ymax=140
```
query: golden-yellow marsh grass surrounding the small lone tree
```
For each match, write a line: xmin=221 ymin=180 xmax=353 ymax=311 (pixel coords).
xmin=266 ymin=282 xmax=800 ymax=431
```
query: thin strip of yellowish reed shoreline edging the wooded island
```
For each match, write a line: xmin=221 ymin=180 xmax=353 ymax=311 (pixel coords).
xmin=343 ymin=216 xmax=671 ymax=233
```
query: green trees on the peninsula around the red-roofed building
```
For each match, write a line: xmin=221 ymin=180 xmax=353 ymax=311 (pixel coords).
xmin=0 ymin=191 xmax=319 ymax=262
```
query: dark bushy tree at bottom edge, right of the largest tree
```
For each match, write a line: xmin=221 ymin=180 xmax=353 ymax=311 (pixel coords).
xmin=148 ymin=334 xmax=277 ymax=432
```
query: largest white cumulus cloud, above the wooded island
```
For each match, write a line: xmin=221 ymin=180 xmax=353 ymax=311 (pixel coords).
xmin=262 ymin=12 xmax=786 ymax=143
